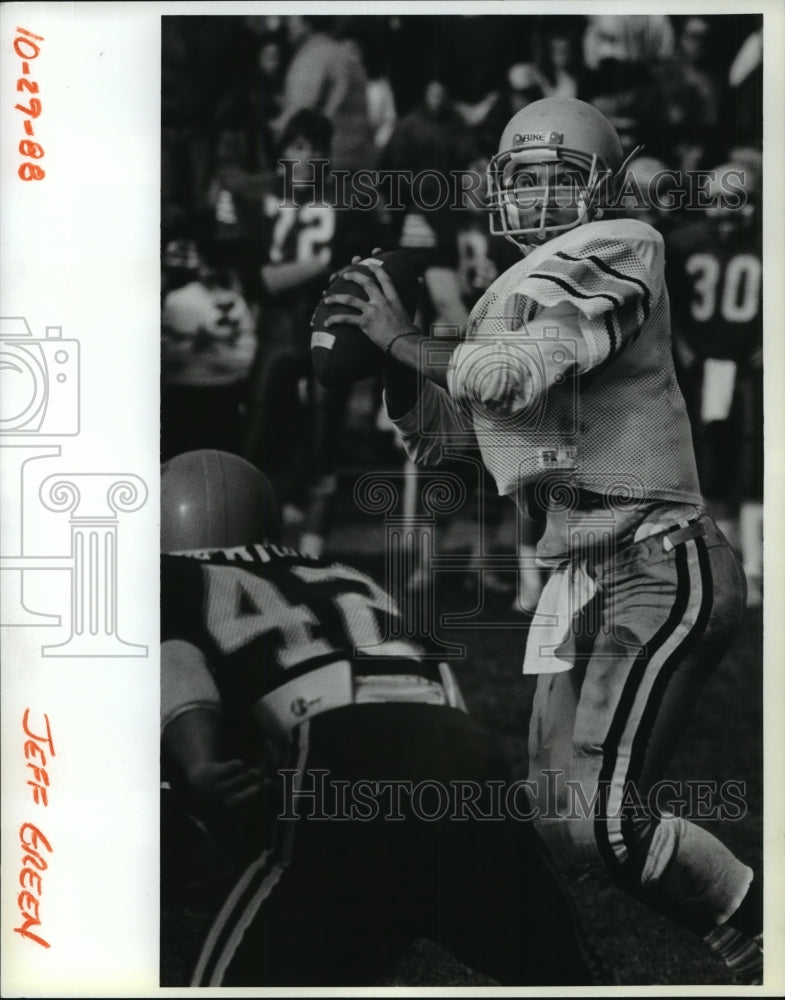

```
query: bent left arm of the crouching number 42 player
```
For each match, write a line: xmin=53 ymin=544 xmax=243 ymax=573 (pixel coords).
xmin=161 ymin=639 xmax=262 ymax=808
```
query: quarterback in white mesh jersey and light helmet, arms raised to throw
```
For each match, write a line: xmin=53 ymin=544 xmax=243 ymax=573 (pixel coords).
xmin=327 ymin=98 xmax=762 ymax=981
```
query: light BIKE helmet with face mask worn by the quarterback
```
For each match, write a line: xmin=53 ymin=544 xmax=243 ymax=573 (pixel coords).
xmin=487 ymin=97 xmax=640 ymax=246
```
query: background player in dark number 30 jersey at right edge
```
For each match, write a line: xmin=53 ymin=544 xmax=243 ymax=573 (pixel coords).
xmin=667 ymin=162 xmax=763 ymax=606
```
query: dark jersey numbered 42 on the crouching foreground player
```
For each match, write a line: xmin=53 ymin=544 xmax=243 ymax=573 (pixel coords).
xmin=161 ymin=545 xmax=454 ymax=739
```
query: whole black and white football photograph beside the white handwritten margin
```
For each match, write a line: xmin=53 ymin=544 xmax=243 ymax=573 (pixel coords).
xmin=161 ymin=8 xmax=765 ymax=987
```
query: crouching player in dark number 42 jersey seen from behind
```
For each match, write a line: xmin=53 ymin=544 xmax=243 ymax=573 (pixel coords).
xmin=161 ymin=451 xmax=590 ymax=986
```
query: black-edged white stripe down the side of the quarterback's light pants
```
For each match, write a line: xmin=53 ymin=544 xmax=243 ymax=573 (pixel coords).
xmin=594 ymin=545 xmax=691 ymax=869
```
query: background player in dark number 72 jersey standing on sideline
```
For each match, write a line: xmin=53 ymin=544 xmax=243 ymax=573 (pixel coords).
xmin=243 ymin=108 xmax=347 ymax=553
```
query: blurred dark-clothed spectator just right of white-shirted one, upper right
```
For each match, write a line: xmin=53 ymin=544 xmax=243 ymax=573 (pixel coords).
xmin=659 ymin=17 xmax=720 ymax=170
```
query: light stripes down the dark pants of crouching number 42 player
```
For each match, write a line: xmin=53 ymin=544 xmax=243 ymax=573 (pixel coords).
xmin=191 ymin=722 xmax=310 ymax=986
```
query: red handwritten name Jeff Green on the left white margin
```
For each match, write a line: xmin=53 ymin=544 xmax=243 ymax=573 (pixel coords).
xmin=14 ymin=708 xmax=56 ymax=948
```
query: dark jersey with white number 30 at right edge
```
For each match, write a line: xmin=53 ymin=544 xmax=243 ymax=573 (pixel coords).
xmin=666 ymin=220 xmax=763 ymax=363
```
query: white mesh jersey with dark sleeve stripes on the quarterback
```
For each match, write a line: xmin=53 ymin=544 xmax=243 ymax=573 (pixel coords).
xmin=397 ymin=219 xmax=701 ymax=556
